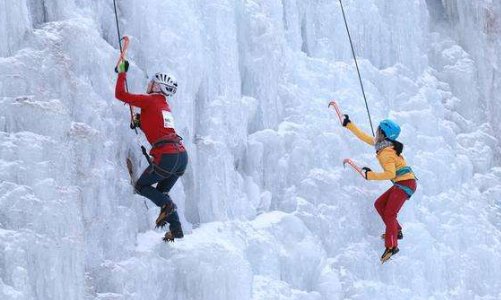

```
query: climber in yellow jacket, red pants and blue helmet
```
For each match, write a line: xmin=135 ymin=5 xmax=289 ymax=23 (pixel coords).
xmin=343 ymin=115 xmax=417 ymax=263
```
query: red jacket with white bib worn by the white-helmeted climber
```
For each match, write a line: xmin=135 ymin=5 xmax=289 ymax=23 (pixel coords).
xmin=115 ymin=73 xmax=186 ymax=163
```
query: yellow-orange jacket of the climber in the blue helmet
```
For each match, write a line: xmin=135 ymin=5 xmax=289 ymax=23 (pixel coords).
xmin=346 ymin=122 xmax=416 ymax=182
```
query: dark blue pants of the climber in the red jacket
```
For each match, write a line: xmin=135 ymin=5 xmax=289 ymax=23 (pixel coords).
xmin=136 ymin=151 xmax=188 ymax=228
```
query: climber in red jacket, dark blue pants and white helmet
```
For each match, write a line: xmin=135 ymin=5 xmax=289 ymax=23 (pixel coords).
xmin=115 ymin=60 xmax=188 ymax=241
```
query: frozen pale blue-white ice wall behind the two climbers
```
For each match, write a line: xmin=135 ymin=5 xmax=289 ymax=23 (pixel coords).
xmin=0 ymin=0 xmax=501 ymax=300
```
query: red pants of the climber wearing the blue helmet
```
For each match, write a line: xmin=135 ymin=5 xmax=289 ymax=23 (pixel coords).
xmin=374 ymin=179 xmax=416 ymax=248
